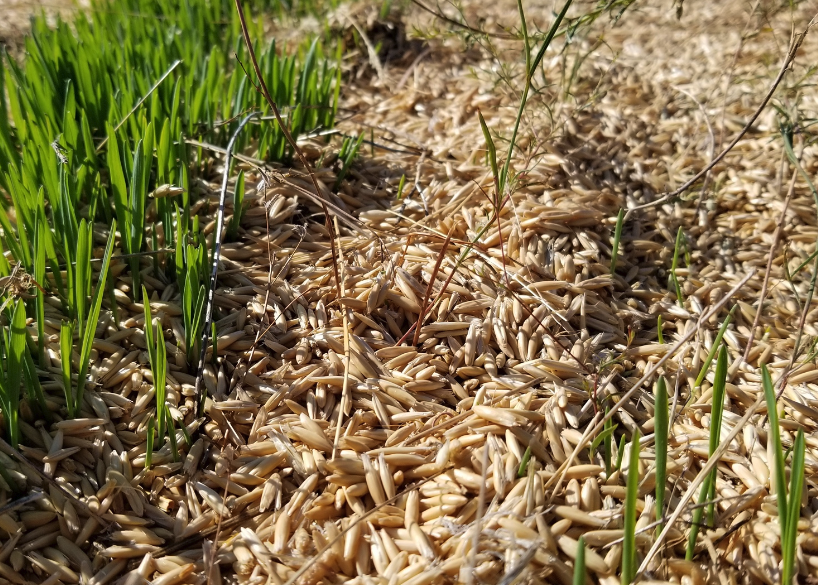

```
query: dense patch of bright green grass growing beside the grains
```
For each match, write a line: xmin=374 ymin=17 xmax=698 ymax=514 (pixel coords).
xmin=0 ymin=0 xmax=342 ymax=434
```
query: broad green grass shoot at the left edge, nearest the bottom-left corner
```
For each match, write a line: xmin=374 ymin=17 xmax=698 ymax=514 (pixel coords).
xmin=0 ymin=301 xmax=28 ymax=448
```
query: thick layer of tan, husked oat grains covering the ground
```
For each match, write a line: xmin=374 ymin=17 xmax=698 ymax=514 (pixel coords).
xmin=0 ymin=0 xmax=818 ymax=585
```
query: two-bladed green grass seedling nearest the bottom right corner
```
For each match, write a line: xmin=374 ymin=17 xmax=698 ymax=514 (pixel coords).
xmin=761 ymin=365 xmax=805 ymax=585
